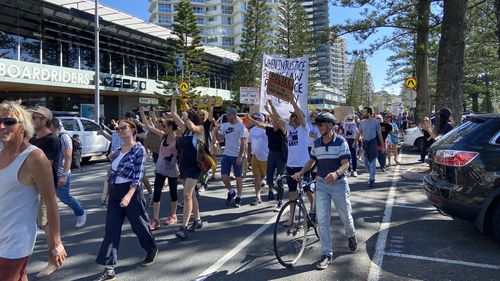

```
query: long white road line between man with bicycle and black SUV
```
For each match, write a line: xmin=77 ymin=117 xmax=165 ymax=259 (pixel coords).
xmin=367 ymin=153 xmax=402 ymax=281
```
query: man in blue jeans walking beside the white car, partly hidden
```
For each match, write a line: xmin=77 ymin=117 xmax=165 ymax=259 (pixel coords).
xmin=50 ymin=118 xmax=87 ymax=228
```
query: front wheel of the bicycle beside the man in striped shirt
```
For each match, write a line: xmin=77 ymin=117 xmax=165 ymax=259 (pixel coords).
xmin=273 ymin=201 xmax=308 ymax=267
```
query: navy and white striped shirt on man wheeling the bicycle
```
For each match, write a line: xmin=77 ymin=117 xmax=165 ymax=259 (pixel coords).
xmin=310 ymin=134 xmax=351 ymax=178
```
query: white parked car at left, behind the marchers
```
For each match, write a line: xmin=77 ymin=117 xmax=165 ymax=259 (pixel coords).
xmin=56 ymin=116 xmax=111 ymax=162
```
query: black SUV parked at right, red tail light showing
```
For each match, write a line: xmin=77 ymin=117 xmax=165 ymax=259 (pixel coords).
xmin=424 ymin=114 xmax=500 ymax=241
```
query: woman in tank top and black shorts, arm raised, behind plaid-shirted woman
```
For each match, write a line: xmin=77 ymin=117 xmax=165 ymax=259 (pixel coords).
xmin=140 ymin=106 xmax=179 ymax=231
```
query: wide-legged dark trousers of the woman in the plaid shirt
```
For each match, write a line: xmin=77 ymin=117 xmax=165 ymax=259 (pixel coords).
xmin=96 ymin=182 xmax=156 ymax=265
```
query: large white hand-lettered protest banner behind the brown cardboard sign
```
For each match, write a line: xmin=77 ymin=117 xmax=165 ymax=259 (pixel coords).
xmin=260 ymin=55 xmax=309 ymax=118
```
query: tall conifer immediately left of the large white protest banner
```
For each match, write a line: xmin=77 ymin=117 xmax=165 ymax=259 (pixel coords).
xmin=231 ymin=0 xmax=271 ymax=101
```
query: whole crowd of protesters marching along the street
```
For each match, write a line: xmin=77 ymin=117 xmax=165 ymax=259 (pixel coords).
xmin=0 ymin=94 xmax=458 ymax=281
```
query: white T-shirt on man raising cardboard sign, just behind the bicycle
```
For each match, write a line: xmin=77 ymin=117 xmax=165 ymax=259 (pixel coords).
xmin=286 ymin=125 xmax=309 ymax=168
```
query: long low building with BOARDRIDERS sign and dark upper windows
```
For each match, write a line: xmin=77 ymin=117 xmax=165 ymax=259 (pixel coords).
xmin=0 ymin=0 xmax=237 ymax=120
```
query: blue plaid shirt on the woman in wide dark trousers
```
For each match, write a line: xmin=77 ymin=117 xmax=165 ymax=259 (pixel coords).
xmin=108 ymin=142 xmax=146 ymax=187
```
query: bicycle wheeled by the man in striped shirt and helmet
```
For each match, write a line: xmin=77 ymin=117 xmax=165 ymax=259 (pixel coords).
xmin=273 ymin=175 xmax=319 ymax=267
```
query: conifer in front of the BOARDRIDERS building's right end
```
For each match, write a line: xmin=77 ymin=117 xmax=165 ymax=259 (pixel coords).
xmin=162 ymin=0 xmax=208 ymax=95
